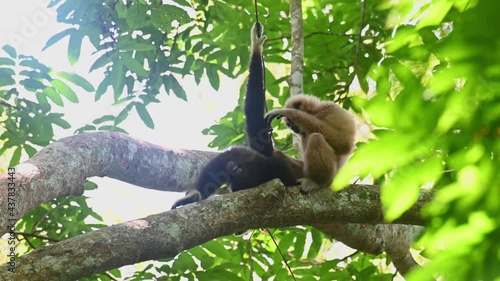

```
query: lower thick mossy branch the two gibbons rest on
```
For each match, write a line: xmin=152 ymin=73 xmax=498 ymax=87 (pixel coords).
xmin=0 ymin=180 xmax=431 ymax=280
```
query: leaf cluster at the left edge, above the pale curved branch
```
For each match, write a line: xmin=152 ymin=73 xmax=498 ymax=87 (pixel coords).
xmin=0 ymin=45 xmax=94 ymax=164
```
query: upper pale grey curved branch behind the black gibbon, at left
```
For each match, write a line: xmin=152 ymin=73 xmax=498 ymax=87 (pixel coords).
xmin=0 ymin=132 xmax=216 ymax=236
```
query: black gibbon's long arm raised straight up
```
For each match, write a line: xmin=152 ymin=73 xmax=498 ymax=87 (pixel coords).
xmin=244 ymin=22 xmax=274 ymax=156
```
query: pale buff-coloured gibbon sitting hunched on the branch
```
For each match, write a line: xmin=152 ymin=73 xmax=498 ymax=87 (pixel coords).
xmin=266 ymin=95 xmax=356 ymax=192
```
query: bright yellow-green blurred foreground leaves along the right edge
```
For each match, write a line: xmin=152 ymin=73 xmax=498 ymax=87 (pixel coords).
xmin=336 ymin=0 xmax=500 ymax=280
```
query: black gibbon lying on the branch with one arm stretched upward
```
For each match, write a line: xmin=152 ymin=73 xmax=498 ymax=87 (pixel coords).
xmin=172 ymin=23 xmax=303 ymax=209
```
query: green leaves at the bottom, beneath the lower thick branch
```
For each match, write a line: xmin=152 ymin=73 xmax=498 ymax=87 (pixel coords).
xmin=121 ymin=227 xmax=386 ymax=280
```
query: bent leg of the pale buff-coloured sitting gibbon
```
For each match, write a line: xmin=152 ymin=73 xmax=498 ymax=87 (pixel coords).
xmin=299 ymin=133 xmax=337 ymax=192
